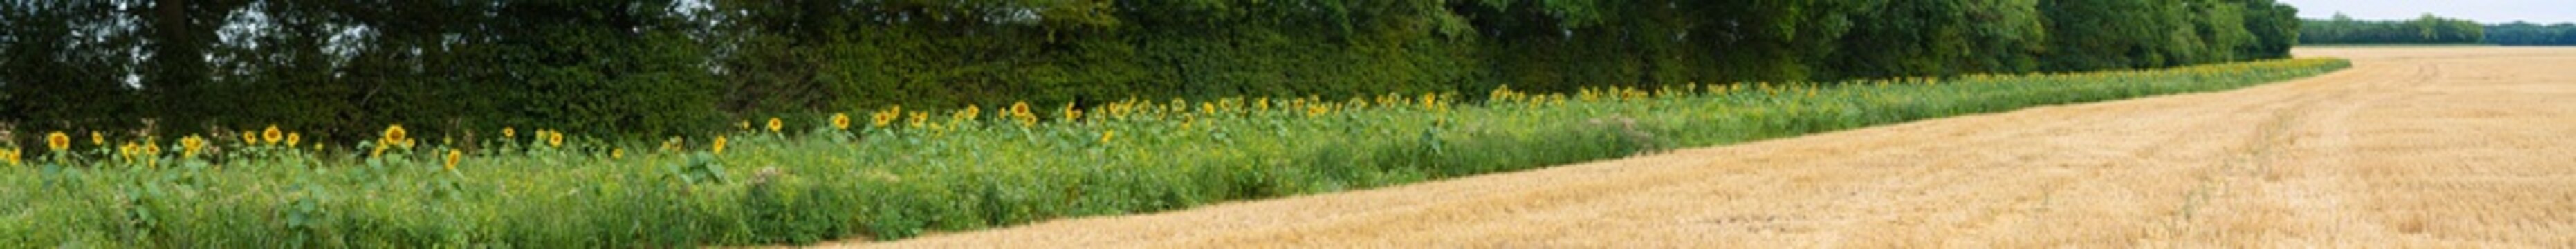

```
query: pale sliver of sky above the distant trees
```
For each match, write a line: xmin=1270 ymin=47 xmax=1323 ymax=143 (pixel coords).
xmin=2280 ymin=0 xmax=2576 ymax=23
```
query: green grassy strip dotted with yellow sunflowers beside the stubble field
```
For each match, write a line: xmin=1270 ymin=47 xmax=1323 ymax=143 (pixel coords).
xmin=0 ymin=59 xmax=2349 ymax=246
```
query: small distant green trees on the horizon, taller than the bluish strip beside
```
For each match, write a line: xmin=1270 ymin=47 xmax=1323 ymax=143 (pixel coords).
xmin=2298 ymin=13 xmax=2486 ymax=44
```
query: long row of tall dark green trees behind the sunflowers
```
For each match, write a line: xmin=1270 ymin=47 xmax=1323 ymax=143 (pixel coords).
xmin=0 ymin=0 xmax=2301 ymax=138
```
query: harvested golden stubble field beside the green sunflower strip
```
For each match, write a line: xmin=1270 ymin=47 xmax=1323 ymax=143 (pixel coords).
xmin=825 ymin=46 xmax=2576 ymax=249
